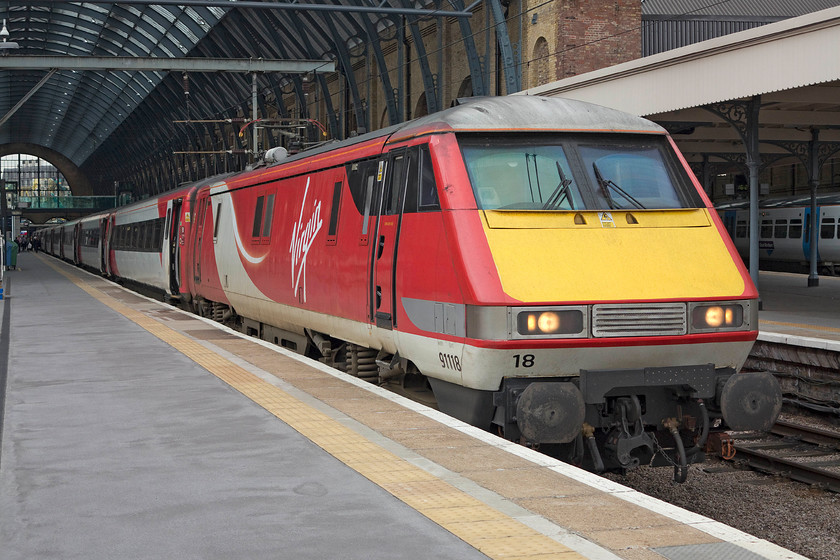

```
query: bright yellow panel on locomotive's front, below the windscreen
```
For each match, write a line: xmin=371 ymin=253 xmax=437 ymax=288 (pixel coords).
xmin=484 ymin=209 xmax=745 ymax=302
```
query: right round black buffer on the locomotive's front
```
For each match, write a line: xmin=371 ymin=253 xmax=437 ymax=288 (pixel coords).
xmin=720 ymin=372 xmax=782 ymax=432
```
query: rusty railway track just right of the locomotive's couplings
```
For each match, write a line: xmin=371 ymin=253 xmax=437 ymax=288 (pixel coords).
xmin=734 ymin=421 xmax=840 ymax=492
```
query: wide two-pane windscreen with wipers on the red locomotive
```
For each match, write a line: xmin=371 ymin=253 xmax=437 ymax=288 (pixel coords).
xmin=459 ymin=134 xmax=703 ymax=211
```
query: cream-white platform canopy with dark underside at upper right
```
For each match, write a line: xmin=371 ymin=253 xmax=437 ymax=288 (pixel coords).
xmin=521 ymin=7 xmax=840 ymax=184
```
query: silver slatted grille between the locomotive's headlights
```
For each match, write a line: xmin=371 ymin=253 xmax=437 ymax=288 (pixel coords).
xmin=592 ymin=303 xmax=686 ymax=338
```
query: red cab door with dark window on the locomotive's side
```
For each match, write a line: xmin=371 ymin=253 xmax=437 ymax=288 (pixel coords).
xmin=371 ymin=148 xmax=417 ymax=329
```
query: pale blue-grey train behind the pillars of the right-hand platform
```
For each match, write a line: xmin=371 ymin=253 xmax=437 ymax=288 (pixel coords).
xmin=717 ymin=194 xmax=840 ymax=275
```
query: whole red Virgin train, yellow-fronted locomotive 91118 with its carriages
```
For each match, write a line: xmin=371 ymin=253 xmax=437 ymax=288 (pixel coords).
xmin=36 ymin=96 xmax=781 ymax=481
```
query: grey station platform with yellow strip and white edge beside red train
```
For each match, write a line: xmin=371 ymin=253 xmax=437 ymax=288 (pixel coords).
xmin=0 ymin=253 xmax=802 ymax=560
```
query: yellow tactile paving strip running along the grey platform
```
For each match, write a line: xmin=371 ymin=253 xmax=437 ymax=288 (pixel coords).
xmin=45 ymin=261 xmax=585 ymax=560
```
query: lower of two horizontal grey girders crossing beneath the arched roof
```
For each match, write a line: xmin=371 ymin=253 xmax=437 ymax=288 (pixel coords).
xmin=0 ymin=55 xmax=335 ymax=74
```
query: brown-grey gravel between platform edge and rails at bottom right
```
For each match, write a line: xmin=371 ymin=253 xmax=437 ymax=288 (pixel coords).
xmin=605 ymin=410 xmax=840 ymax=560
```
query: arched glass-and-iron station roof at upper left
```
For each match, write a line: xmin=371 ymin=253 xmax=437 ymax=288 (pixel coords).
xmin=0 ymin=0 xmax=519 ymax=194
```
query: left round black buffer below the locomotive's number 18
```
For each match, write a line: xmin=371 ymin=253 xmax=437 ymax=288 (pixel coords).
xmin=516 ymin=382 xmax=585 ymax=443
